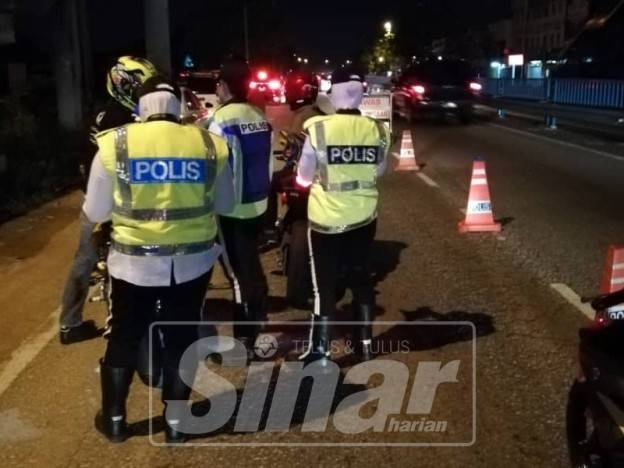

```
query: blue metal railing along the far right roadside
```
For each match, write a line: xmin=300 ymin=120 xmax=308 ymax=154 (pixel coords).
xmin=481 ymin=78 xmax=624 ymax=109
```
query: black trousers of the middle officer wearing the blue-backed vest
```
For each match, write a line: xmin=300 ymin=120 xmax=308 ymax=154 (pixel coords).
xmin=219 ymin=216 xmax=269 ymax=310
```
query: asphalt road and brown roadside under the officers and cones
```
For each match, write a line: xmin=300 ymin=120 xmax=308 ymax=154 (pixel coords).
xmin=0 ymin=108 xmax=624 ymax=467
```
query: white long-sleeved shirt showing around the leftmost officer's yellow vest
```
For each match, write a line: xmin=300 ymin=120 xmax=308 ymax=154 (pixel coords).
xmin=82 ymin=153 xmax=234 ymax=287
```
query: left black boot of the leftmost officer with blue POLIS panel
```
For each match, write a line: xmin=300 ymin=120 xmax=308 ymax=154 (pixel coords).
xmin=95 ymin=361 xmax=134 ymax=443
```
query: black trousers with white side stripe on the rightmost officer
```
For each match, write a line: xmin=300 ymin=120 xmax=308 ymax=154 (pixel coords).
xmin=309 ymin=221 xmax=377 ymax=318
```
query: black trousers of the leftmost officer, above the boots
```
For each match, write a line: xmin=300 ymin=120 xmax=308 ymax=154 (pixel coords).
xmin=104 ymin=272 xmax=211 ymax=369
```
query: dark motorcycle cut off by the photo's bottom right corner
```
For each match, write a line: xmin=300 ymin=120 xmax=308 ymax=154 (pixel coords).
xmin=566 ymin=291 xmax=624 ymax=468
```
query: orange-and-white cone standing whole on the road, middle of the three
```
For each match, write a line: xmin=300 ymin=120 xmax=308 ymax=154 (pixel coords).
xmin=459 ymin=159 xmax=502 ymax=233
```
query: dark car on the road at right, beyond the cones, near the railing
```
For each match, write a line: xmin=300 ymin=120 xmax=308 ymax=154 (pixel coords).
xmin=393 ymin=60 xmax=482 ymax=124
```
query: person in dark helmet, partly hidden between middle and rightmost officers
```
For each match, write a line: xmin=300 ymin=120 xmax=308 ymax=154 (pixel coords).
xmin=265 ymin=71 xmax=325 ymax=239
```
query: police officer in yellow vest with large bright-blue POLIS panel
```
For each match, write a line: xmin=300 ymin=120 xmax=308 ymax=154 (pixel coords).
xmin=83 ymin=77 xmax=234 ymax=443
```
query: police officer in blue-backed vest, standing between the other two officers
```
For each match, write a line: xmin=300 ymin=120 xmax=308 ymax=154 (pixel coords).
xmin=208 ymin=57 xmax=272 ymax=358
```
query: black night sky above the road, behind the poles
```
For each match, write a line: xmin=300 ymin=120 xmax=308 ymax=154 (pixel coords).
xmin=14 ymin=0 xmax=511 ymax=72
